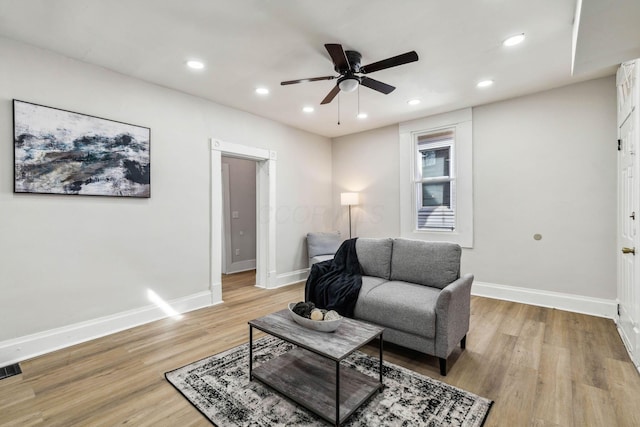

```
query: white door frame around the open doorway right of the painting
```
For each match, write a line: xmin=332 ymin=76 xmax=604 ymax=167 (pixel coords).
xmin=209 ymin=138 xmax=277 ymax=304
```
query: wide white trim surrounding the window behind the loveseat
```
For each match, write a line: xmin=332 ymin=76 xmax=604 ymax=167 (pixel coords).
xmin=399 ymin=108 xmax=473 ymax=248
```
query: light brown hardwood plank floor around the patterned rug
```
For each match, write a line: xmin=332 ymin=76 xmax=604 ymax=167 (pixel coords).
xmin=0 ymin=272 xmax=640 ymax=427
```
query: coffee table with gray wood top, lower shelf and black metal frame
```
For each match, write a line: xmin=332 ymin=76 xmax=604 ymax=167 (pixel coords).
xmin=249 ymin=309 xmax=384 ymax=426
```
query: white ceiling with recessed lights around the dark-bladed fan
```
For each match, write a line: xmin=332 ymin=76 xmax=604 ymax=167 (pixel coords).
xmin=0 ymin=0 xmax=640 ymax=137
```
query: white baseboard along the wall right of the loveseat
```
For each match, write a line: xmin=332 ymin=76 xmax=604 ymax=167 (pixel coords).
xmin=471 ymin=282 xmax=618 ymax=319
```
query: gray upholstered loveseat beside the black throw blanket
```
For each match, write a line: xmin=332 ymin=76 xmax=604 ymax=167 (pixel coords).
xmin=354 ymin=238 xmax=473 ymax=375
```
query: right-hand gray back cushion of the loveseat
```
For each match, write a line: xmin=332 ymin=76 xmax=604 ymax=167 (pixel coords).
xmin=391 ymin=239 xmax=462 ymax=289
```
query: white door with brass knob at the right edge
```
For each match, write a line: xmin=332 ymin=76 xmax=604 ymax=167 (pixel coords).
xmin=618 ymin=59 xmax=640 ymax=365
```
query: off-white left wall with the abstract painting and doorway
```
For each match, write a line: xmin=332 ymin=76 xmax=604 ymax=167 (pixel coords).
xmin=0 ymin=38 xmax=332 ymax=352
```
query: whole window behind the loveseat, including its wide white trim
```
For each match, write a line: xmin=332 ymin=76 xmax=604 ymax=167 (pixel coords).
xmin=399 ymin=108 xmax=473 ymax=248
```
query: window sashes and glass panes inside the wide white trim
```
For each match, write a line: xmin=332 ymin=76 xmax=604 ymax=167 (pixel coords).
xmin=415 ymin=129 xmax=456 ymax=230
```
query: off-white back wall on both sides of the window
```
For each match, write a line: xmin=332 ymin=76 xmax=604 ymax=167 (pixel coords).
xmin=332 ymin=77 xmax=617 ymax=301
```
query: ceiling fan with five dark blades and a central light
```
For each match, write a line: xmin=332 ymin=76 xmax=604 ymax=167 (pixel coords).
xmin=280 ymin=43 xmax=418 ymax=104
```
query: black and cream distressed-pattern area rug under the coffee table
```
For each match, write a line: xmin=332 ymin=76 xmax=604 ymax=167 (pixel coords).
xmin=165 ymin=337 xmax=493 ymax=427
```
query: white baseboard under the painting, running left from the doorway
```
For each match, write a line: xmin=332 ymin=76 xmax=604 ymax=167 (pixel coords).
xmin=0 ymin=291 xmax=221 ymax=366
